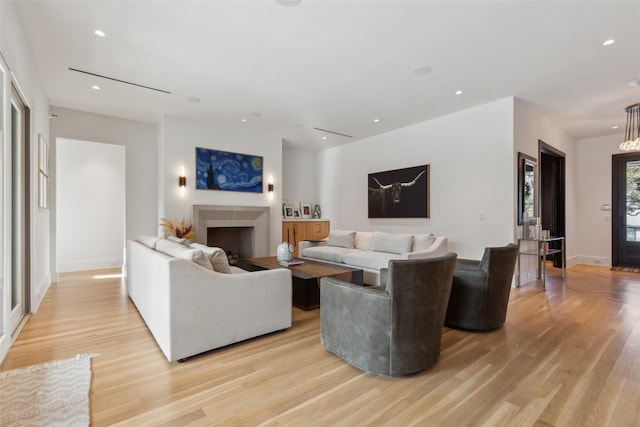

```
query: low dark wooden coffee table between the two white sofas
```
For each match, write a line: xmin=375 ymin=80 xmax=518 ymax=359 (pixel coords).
xmin=243 ymin=257 xmax=363 ymax=310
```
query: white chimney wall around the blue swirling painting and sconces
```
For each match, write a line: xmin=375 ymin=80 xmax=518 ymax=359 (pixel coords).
xmin=158 ymin=117 xmax=282 ymax=255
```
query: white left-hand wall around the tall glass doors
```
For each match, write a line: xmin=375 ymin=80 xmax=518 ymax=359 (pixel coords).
xmin=0 ymin=1 xmax=51 ymax=361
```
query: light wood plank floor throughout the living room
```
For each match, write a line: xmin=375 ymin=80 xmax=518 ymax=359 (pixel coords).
xmin=0 ymin=266 xmax=640 ymax=426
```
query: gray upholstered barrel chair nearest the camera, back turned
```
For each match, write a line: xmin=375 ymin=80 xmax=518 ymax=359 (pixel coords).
xmin=320 ymin=253 xmax=457 ymax=376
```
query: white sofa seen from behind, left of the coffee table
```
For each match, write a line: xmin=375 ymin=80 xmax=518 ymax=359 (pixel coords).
xmin=126 ymin=236 xmax=291 ymax=362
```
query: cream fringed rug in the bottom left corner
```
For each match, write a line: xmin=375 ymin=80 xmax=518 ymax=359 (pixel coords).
xmin=0 ymin=354 xmax=98 ymax=427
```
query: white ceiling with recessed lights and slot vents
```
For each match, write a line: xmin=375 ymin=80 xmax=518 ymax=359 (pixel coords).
xmin=13 ymin=0 xmax=640 ymax=150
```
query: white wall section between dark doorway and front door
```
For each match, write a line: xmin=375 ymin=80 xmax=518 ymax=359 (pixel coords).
xmin=576 ymin=134 xmax=624 ymax=266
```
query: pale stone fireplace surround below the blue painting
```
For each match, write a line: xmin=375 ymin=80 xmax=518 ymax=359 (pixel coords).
xmin=191 ymin=205 xmax=270 ymax=257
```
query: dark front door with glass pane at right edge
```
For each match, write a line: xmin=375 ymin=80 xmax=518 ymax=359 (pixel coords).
xmin=611 ymin=153 xmax=640 ymax=267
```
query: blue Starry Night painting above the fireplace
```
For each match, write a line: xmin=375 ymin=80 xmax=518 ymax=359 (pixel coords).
xmin=196 ymin=147 xmax=262 ymax=193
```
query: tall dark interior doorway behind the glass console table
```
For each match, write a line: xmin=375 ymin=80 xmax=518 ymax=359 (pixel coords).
xmin=538 ymin=141 xmax=566 ymax=267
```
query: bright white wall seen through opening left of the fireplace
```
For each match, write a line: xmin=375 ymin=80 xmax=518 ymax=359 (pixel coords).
xmin=56 ymin=138 xmax=126 ymax=272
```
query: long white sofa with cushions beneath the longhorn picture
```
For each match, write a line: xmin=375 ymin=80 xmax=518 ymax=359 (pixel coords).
xmin=298 ymin=230 xmax=448 ymax=285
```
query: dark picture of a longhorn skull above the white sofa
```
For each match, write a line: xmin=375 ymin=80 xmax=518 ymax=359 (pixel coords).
xmin=368 ymin=165 xmax=429 ymax=218
